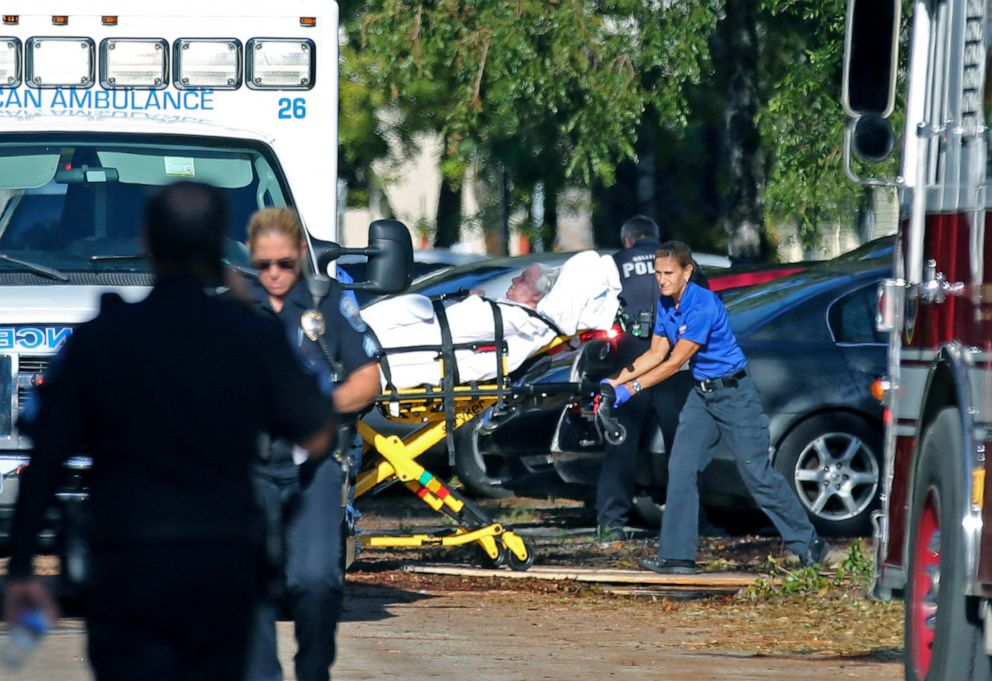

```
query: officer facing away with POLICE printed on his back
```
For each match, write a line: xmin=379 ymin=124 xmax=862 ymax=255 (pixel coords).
xmin=596 ymin=215 xmax=661 ymax=541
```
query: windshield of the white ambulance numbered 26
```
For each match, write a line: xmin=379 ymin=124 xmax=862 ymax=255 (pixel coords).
xmin=0 ymin=134 xmax=291 ymax=276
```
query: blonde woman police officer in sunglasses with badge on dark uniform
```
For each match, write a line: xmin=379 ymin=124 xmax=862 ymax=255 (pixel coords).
xmin=246 ymin=208 xmax=380 ymax=681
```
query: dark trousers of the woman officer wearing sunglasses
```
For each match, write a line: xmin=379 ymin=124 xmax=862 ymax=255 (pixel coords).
xmin=245 ymin=457 xmax=344 ymax=681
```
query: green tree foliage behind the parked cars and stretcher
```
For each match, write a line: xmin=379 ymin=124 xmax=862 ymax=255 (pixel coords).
xmin=339 ymin=0 xmax=892 ymax=255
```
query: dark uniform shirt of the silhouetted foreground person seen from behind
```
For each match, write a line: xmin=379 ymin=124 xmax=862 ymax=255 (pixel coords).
xmin=9 ymin=277 xmax=333 ymax=576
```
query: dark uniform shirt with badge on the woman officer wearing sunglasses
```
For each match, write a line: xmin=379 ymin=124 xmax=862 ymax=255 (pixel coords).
xmin=252 ymin=277 xmax=379 ymax=478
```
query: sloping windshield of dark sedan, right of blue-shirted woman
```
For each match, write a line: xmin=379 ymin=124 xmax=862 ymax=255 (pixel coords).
xmin=723 ymin=268 xmax=876 ymax=337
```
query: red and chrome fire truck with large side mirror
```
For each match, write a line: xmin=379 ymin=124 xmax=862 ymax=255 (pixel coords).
xmin=842 ymin=0 xmax=992 ymax=681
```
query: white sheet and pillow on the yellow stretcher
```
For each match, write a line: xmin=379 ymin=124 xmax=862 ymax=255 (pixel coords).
xmin=362 ymin=251 xmax=620 ymax=388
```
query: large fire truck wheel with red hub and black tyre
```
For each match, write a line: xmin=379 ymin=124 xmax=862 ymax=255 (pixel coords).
xmin=905 ymin=407 xmax=990 ymax=681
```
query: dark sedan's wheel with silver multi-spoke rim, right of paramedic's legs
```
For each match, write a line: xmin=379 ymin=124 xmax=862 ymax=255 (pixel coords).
xmin=775 ymin=412 xmax=882 ymax=537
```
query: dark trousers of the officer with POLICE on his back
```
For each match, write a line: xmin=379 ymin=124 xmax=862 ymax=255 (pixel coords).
xmin=596 ymin=388 xmax=653 ymax=528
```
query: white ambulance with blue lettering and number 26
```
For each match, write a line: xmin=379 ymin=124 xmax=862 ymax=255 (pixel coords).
xmin=0 ymin=0 xmax=409 ymax=544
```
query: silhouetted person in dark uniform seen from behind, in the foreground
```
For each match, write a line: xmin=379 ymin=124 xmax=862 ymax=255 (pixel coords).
xmin=4 ymin=182 xmax=333 ymax=681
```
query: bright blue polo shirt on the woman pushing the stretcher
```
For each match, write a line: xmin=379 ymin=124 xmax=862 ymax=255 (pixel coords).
xmin=654 ymin=281 xmax=747 ymax=381
